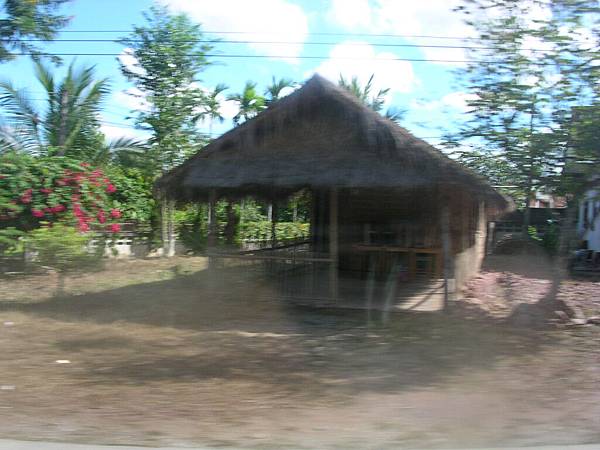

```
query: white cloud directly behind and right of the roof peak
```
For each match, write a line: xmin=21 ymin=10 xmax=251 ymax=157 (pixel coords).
xmin=305 ymin=41 xmax=418 ymax=93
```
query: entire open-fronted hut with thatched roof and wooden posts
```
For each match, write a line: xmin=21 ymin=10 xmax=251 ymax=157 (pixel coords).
xmin=157 ymin=75 xmax=507 ymax=310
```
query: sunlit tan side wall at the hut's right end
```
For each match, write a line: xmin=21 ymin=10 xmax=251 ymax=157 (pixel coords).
xmin=454 ymin=202 xmax=487 ymax=289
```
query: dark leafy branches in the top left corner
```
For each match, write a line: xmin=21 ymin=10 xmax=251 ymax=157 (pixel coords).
xmin=0 ymin=0 xmax=70 ymax=62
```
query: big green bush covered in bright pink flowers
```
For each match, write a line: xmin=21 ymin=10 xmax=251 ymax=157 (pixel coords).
xmin=0 ymin=153 xmax=121 ymax=250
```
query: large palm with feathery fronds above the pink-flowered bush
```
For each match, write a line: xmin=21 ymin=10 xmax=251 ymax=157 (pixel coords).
xmin=0 ymin=61 xmax=109 ymax=159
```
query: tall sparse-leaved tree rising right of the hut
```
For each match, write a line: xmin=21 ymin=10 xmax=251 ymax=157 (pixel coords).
xmin=455 ymin=0 xmax=591 ymax=230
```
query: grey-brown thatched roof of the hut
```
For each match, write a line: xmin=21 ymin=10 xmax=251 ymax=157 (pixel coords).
xmin=156 ymin=75 xmax=504 ymax=207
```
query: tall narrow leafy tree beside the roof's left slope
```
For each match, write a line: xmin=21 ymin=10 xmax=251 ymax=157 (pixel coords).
xmin=120 ymin=7 xmax=212 ymax=175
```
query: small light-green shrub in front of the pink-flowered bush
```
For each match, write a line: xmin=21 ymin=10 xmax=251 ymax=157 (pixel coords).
xmin=25 ymin=223 xmax=104 ymax=272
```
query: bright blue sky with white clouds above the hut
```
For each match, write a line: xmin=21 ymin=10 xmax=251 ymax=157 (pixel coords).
xmin=0 ymin=0 xmax=488 ymax=144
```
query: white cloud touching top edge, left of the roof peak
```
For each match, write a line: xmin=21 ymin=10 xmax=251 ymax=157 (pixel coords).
xmin=159 ymin=0 xmax=308 ymax=63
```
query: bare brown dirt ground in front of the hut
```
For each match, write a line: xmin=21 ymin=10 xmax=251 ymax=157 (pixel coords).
xmin=0 ymin=257 xmax=600 ymax=449
